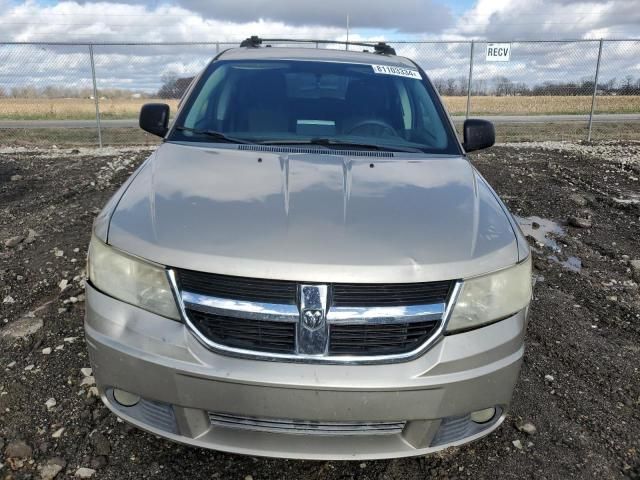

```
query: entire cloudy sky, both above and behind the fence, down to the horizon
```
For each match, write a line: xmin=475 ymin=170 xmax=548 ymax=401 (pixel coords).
xmin=0 ymin=0 xmax=640 ymax=93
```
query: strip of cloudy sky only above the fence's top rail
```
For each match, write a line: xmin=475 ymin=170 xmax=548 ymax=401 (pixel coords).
xmin=0 ymin=0 xmax=640 ymax=42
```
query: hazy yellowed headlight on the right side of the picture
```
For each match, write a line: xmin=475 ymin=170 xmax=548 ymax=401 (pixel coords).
xmin=447 ymin=255 xmax=532 ymax=332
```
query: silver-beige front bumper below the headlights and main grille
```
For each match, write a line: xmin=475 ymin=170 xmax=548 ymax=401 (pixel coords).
xmin=85 ymin=285 xmax=526 ymax=460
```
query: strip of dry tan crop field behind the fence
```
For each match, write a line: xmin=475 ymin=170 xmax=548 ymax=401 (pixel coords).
xmin=0 ymin=95 xmax=640 ymax=120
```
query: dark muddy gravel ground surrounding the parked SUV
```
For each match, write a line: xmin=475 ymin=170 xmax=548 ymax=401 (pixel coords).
xmin=0 ymin=142 xmax=640 ymax=480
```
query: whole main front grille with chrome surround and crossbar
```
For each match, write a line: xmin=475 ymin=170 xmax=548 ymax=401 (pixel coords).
xmin=176 ymin=270 xmax=456 ymax=362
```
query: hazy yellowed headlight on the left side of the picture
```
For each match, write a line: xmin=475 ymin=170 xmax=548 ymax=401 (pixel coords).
xmin=88 ymin=236 xmax=180 ymax=320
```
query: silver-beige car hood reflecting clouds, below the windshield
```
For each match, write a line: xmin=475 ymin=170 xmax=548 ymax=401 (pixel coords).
xmin=108 ymin=143 xmax=518 ymax=283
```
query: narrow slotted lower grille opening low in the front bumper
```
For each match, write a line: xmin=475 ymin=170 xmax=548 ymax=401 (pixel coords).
xmin=209 ymin=412 xmax=406 ymax=436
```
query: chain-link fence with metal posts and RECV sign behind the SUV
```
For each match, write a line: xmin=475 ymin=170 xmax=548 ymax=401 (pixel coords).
xmin=0 ymin=40 xmax=640 ymax=145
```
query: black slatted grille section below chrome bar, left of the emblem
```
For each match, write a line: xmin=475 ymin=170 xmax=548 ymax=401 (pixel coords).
xmin=187 ymin=310 xmax=296 ymax=353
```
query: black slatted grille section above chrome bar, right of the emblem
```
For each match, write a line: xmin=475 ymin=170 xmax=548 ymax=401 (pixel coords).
xmin=333 ymin=281 xmax=454 ymax=307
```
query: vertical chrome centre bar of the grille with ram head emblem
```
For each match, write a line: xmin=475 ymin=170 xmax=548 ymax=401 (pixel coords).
xmin=296 ymin=285 xmax=329 ymax=355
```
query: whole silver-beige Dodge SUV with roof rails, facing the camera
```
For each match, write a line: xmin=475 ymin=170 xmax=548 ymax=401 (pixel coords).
xmin=85 ymin=38 xmax=531 ymax=459
